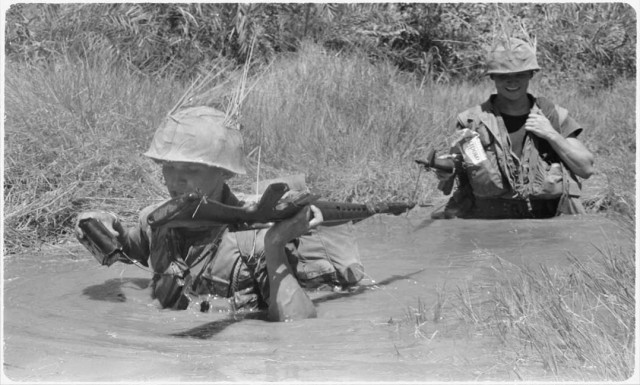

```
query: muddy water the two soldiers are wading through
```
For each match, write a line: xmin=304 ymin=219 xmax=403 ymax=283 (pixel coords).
xmin=3 ymin=210 xmax=632 ymax=382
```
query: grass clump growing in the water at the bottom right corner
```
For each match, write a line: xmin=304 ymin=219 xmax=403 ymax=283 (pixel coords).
xmin=457 ymin=226 xmax=635 ymax=380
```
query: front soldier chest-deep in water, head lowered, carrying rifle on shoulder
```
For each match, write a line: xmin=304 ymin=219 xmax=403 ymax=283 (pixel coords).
xmin=76 ymin=107 xmax=364 ymax=321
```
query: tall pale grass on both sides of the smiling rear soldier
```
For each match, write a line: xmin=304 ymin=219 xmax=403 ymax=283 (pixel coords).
xmin=240 ymin=42 xmax=635 ymax=208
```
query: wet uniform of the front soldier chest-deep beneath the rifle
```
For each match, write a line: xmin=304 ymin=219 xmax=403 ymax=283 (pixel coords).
xmin=117 ymin=185 xmax=364 ymax=309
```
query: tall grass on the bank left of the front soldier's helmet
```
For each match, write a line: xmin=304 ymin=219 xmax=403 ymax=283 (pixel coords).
xmin=4 ymin=57 xmax=177 ymax=251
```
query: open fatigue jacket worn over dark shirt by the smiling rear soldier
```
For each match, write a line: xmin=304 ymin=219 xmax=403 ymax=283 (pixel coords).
xmin=439 ymin=95 xmax=584 ymax=214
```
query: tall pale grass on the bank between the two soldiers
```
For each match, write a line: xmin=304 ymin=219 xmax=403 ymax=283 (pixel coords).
xmin=244 ymin=43 xmax=464 ymax=200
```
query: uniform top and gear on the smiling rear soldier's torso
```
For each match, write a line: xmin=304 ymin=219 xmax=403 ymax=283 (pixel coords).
xmin=439 ymin=95 xmax=584 ymax=219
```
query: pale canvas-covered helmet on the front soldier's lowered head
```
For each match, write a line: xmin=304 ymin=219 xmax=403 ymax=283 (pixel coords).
xmin=144 ymin=106 xmax=246 ymax=174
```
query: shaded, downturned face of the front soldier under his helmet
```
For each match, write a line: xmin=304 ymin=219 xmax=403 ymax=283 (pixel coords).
xmin=162 ymin=162 xmax=233 ymax=200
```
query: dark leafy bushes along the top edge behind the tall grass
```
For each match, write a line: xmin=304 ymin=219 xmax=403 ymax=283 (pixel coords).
xmin=5 ymin=3 xmax=637 ymax=83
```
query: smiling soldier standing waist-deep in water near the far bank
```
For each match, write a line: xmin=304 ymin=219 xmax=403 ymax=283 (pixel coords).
xmin=432 ymin=38 xmax=593 ymax=219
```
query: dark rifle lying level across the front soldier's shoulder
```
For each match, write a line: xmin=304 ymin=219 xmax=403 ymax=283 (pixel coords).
xmin=147 ymin=183 xmax=415 ymax=231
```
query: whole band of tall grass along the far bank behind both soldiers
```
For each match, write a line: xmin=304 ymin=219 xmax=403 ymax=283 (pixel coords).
xmin=4 ymin=44 xmax=635 ymax=252
